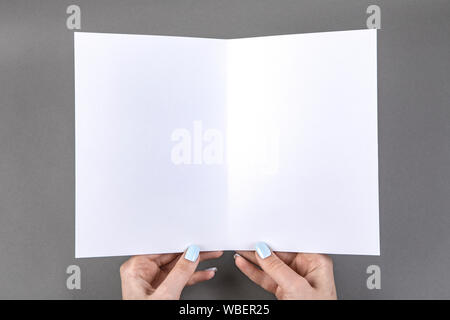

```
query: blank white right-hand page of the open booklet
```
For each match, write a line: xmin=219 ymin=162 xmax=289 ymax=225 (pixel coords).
xmin=227 ymin=30 xmax=379 ymax=255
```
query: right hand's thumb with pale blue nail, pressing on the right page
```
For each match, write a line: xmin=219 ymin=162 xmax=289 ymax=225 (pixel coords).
xmin=255 ymin=242 xmax=306 ymax=290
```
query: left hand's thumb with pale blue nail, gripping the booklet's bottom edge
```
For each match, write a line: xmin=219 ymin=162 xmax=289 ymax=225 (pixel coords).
xmin=157 ymin=245 xmax=200 ymax=298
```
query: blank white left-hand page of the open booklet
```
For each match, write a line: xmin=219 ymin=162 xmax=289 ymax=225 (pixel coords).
xmin=75 ymin=32 xmax=226 ymax=257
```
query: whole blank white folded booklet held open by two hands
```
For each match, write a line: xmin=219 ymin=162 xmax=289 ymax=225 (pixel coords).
xmin=74 ymin=30 xmax=380 ymax=257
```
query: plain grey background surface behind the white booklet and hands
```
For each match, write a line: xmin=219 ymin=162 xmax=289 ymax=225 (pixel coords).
xmin=0 ymin=0 xmax=450 ymax=299
